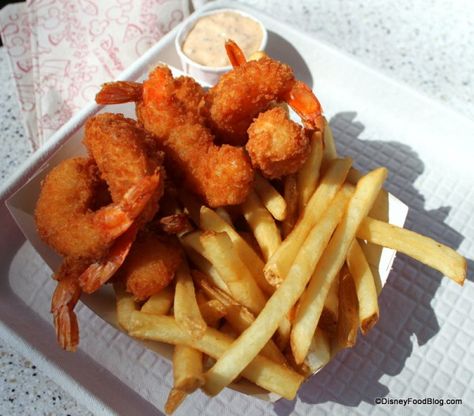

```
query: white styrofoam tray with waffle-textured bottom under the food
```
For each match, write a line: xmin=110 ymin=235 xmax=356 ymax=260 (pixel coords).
xmin=0 ymin=1 xmax=474 ymax=416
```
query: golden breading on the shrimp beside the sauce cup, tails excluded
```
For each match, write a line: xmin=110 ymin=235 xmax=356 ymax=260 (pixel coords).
xmin=205 ymin=58 xmax=295 ymax=145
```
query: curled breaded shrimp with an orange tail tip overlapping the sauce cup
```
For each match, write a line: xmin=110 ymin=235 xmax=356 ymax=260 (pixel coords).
xmin=201 ymin=41 xmax=323 ymax=145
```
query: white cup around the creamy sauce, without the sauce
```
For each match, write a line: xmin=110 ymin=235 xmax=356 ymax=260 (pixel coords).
xmin=175 ymin=9 xmax=268 ymax=85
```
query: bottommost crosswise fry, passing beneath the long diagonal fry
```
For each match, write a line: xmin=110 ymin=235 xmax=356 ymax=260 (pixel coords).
xmin=130 ymin=311 xmax=303 ymax=400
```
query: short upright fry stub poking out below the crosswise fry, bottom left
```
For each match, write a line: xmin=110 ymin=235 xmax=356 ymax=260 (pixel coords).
xmin=173 ymin=344 xmax=204 ymax=393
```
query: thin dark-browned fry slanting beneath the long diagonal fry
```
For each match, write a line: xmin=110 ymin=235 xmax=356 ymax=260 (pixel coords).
xmin=192 ymin=271 xmax=288 ymax=365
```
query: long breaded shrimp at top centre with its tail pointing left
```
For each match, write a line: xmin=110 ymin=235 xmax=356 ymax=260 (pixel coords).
xmin=96 ymin=66 xmax=253 ymax=207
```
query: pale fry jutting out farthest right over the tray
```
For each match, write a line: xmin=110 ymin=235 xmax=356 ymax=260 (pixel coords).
xmin=357 ymin=218 xmax=467 ymax=286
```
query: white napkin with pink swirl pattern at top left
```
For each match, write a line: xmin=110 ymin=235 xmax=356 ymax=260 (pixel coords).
xmin=0 ymin=0 xmax=189 ymax=148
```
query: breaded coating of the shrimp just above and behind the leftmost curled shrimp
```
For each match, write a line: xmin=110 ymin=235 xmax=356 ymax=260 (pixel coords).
xmin=84 ymin=113 xmax=163 ymax=222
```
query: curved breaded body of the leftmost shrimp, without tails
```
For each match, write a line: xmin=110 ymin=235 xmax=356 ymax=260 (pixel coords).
xmin=35 ymin=157 xmax=111 ymax=258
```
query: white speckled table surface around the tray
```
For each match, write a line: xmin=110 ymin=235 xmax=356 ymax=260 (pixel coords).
xmin=0 ymin=0 xmax=474 ymax=415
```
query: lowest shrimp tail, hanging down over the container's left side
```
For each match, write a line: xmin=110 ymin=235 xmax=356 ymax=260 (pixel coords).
xmin=51 ymin=275 xmax=81 ymax=352
